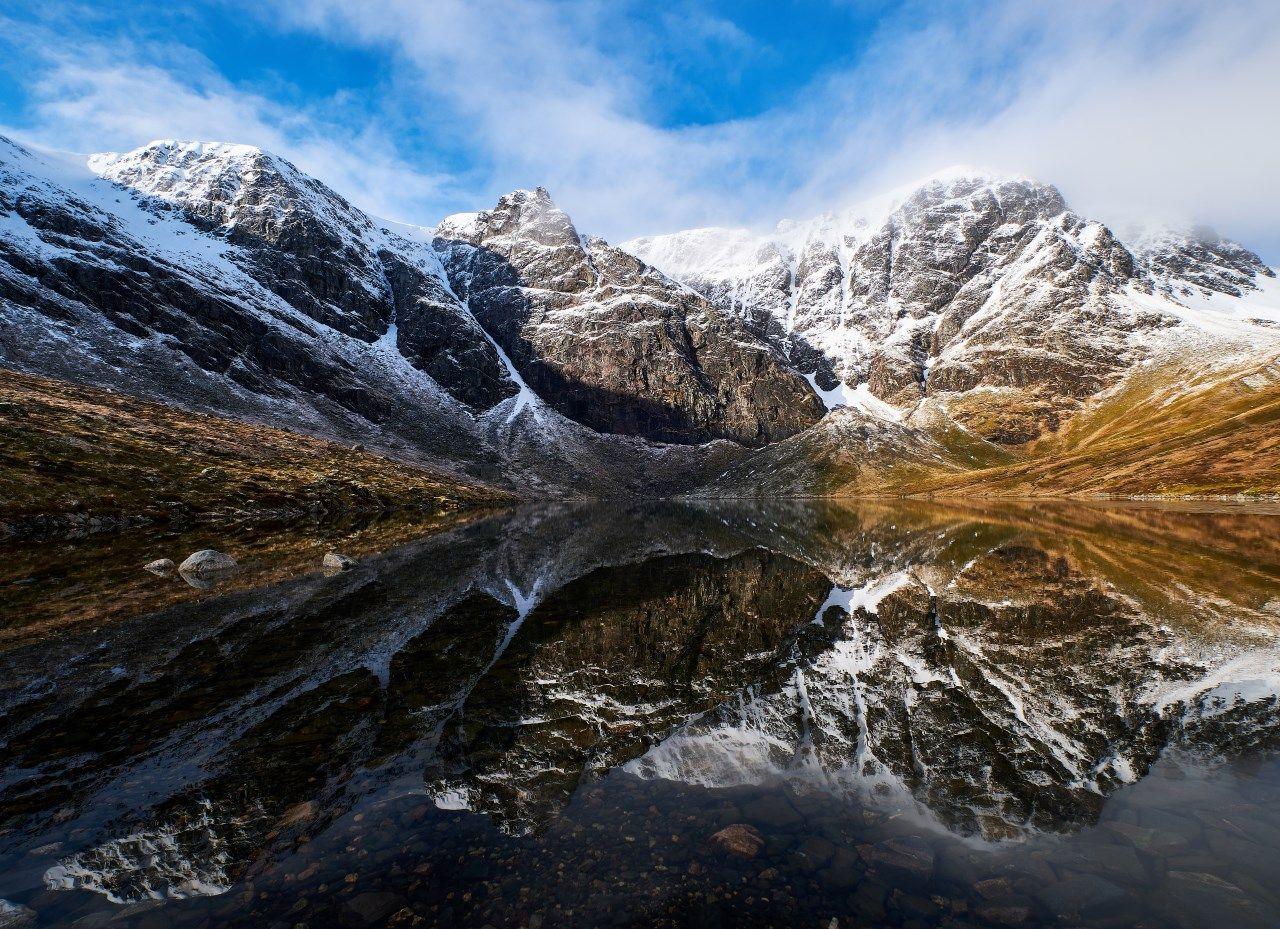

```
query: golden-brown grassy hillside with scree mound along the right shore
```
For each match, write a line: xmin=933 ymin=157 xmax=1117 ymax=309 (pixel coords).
xmin=701 ymin=356 xmax=1280 ymax=498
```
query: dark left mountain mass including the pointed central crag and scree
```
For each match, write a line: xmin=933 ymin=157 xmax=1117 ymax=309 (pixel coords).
xmin=0 ymin=139 xmax=808 ymax=493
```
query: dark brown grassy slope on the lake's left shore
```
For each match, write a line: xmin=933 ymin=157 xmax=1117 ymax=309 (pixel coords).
xmin=0 ymin=370 xmax=507 ymax=536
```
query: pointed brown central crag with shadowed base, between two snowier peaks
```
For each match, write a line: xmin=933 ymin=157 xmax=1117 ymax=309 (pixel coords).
xmin=436 ymin=188 xmax=823 ymax=445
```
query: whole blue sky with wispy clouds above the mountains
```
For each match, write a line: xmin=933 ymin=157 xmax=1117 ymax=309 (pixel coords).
xmin=0 ymin=0 xmax=1280 ymax=261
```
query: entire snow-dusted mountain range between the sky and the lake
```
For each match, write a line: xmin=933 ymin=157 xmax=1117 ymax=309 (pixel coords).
xmin=0 ymin=139 xmax=1280 ymax=496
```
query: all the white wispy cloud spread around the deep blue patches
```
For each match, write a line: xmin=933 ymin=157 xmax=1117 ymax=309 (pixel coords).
xmin=5 ymin=0 xmax=1280 ymax=260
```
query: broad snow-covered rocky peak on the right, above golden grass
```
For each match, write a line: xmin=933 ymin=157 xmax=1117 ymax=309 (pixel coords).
xmin=622 ymin=169 xmax=1275 ymax=444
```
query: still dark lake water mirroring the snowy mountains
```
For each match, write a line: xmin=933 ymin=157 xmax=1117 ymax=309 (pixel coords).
xmin=0 ymin=503 xmax=1280 ymax=929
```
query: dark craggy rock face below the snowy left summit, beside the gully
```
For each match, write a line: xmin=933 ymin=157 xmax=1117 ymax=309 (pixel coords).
xmin=90 ymin=141 xmax=515 ymax=409
